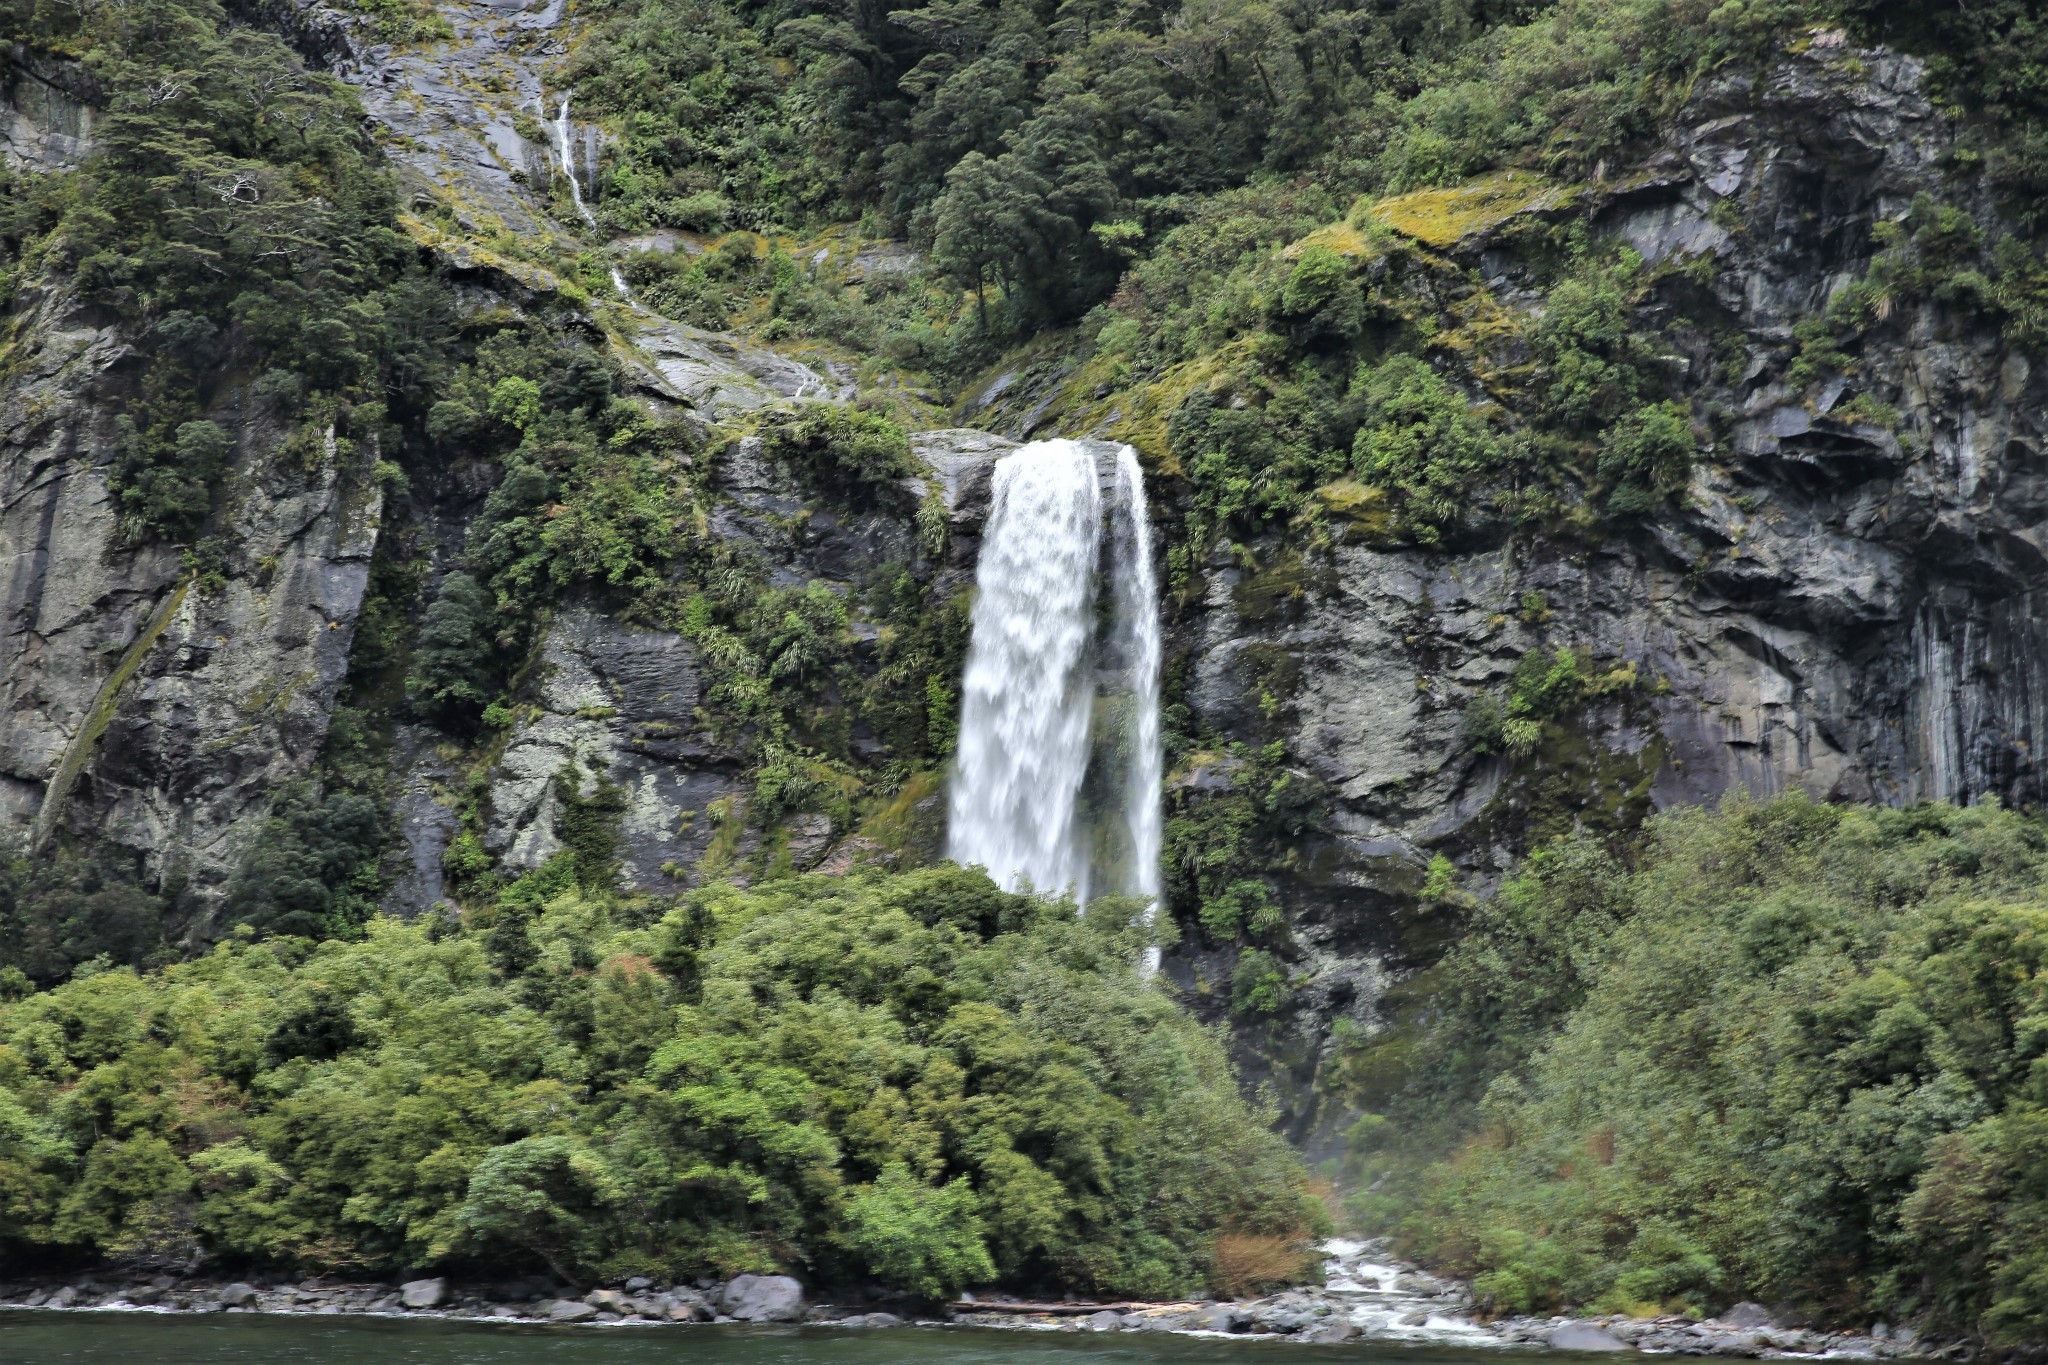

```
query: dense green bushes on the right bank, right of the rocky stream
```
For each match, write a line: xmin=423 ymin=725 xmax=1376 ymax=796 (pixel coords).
xmin=1362 ymin=796 xmax=2048 ymax=1342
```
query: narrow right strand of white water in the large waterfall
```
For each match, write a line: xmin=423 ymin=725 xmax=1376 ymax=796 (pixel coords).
xmin=1112 ymin=446 xmax=1165 ymax=970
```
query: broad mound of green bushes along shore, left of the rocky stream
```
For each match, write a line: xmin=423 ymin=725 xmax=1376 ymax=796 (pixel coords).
xmin=0 ymin=868 xmax=1321 ymax=1295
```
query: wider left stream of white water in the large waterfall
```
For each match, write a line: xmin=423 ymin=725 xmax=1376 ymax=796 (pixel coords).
xmin=946 ymin=440 xmax=1102 ymax=898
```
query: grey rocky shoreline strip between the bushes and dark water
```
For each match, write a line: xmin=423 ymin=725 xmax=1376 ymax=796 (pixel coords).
xmin=0 ymin=1240 xmax=1978 ymax=1361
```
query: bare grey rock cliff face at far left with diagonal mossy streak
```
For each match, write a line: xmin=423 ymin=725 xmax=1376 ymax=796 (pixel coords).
xmin=0 ymin=272 xmax=383 ymax=933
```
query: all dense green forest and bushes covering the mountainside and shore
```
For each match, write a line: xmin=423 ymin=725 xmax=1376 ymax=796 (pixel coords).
xmin=0 ymin=0 xmax=2048 ymax=1345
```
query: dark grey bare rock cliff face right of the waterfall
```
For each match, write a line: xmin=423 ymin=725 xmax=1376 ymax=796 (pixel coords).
xmin=973 ymin=35 xmax=2048 ymax=1132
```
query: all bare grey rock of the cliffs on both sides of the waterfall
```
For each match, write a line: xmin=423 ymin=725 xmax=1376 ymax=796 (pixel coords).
xmin=0 ymin=13 xmax=2048 ymax=1132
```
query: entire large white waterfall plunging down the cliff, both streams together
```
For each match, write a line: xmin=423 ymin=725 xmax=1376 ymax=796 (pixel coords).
xmin=946 ymin=440 xmax=1159 ymax=933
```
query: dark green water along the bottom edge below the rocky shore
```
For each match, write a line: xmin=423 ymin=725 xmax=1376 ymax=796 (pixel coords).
xmin=0 ymin=1312 xmax=1523 ymax=1365
